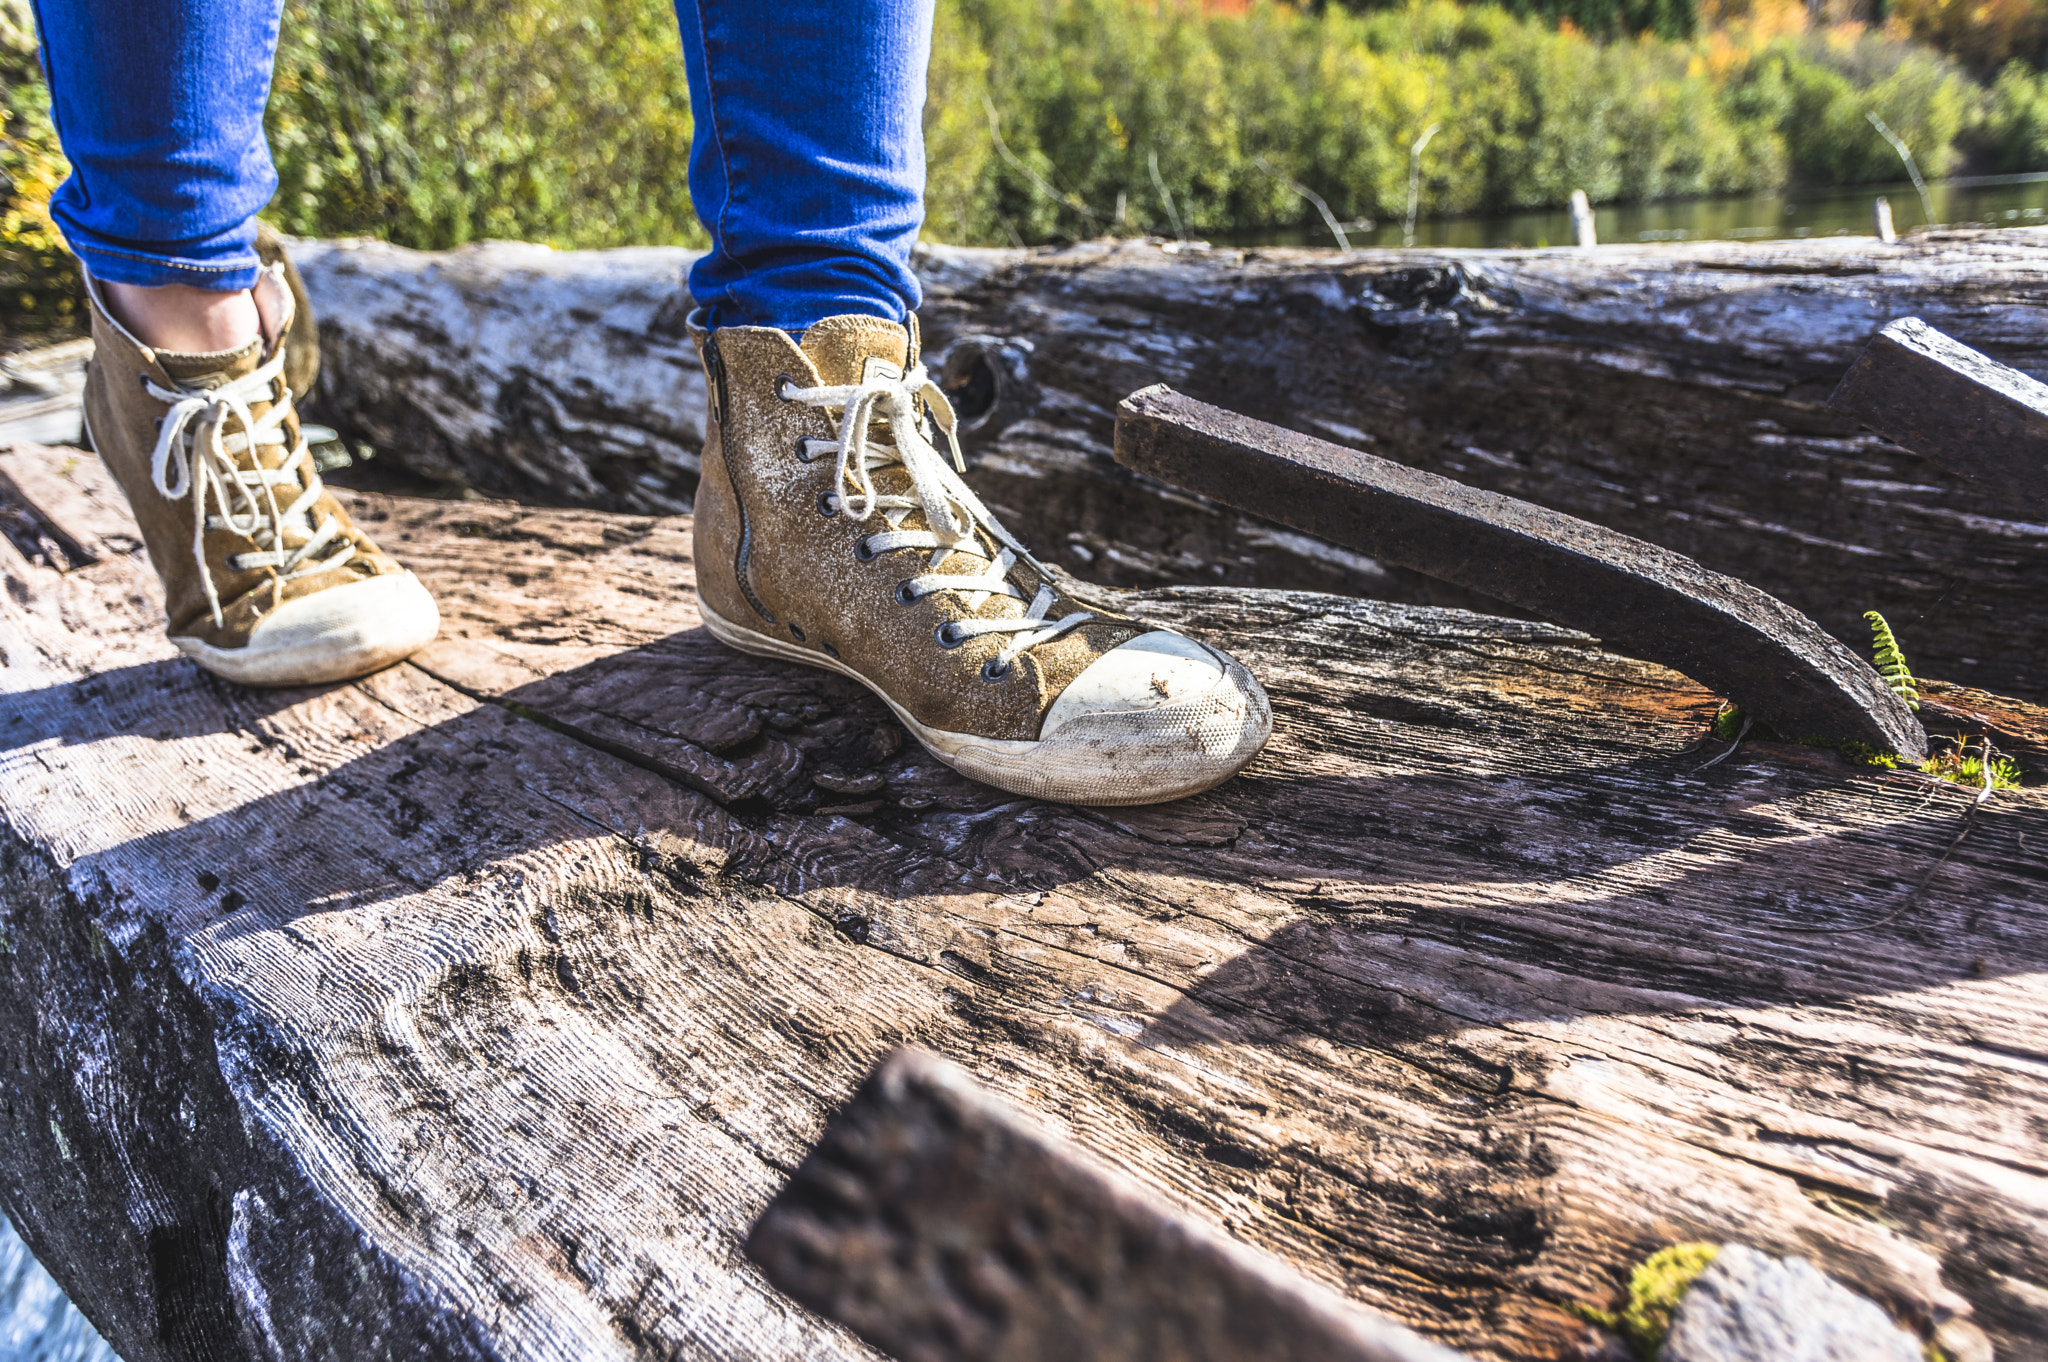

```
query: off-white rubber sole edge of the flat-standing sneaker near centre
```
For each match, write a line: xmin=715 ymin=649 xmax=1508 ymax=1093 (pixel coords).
xmin=698 ymin=598 xmax=1272 ymax=805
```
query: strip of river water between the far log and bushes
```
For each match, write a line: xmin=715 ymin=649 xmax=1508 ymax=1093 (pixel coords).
xmin=1214 ymin=174 xmax=2048 ymax=248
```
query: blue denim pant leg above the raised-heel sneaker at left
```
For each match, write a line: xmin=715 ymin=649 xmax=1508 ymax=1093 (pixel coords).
xmin=35 ymin=0 xmax=283 ymax=291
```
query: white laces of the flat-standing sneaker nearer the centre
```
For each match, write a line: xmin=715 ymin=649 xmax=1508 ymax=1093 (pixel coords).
xmin=780 ymin=365 xmax=1096 ymax=676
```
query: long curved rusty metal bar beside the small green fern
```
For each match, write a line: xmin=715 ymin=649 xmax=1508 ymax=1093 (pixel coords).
xmin=1116 ymin=385 xmax=1927 ymax=760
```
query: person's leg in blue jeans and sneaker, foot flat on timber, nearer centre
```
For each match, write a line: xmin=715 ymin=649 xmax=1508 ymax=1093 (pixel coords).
xmin=678 ymin=0 xmax=1272 ymax=805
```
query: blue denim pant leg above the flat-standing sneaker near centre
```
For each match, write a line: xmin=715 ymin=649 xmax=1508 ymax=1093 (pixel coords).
xmin=676 ymin=0 xmax=932 ymax=332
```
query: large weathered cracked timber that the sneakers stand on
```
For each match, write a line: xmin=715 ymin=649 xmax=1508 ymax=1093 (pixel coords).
xmin=0 ymin=449 xmax=2048 ymax=1362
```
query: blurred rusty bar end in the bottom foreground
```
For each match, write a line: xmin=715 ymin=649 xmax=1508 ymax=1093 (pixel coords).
xmin=748 ymin=1049 xmax=1458 ymax=1362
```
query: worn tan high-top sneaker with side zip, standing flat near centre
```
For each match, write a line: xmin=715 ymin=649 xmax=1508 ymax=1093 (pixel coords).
xmin=696 ymin=317 xmax=1272 ymax=805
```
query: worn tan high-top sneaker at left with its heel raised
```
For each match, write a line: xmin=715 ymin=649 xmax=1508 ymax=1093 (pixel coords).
xmin=86 ymin=266 xmax=440 ymax=686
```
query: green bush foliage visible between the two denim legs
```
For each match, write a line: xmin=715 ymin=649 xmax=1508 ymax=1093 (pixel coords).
xmin=266 ymin=0 xmax=707 ymax=246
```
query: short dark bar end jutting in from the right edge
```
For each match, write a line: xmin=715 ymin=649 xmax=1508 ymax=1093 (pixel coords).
xmin=1827 ymin=317 xmax=2048 ymax=514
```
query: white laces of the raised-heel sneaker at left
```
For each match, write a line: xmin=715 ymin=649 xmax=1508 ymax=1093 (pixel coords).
xmin=143 ymin=346 xmax=356 ymax=625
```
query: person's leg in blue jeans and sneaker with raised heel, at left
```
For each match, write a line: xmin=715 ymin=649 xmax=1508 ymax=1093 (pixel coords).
xmin=37 ymin=0 xmax=440 ymax=686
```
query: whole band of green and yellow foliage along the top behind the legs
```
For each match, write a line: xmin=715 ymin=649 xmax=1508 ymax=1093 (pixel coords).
xmin=12 ymin=0 xmax=2048 ymax=332
